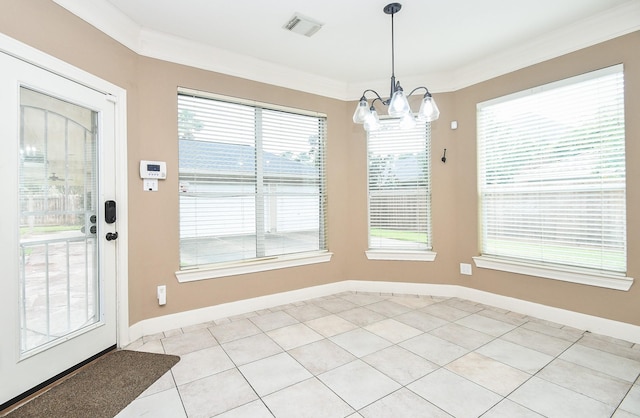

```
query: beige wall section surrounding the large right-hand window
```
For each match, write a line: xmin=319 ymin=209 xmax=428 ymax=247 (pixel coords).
xmin=451 ymin=32 xmax=640 ymax=325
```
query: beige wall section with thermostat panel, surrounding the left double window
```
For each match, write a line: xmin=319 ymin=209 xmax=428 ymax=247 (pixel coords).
xmin=129 ymin=58 xmax=349 ymax=323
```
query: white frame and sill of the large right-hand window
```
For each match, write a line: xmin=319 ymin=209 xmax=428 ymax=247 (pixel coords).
xmin=473 ymin=64 xmax=634 ymax=291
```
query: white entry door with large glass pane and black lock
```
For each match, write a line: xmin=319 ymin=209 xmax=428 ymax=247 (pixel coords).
xmin=0 ymin=52 xmax=118 ymax=405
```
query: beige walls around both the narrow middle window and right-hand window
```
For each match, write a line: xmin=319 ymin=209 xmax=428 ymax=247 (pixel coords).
xmin=348 ymin=32 xmax=640 ymax=325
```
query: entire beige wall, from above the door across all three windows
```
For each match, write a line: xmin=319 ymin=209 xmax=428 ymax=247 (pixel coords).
xmin=0 ymin=0 xmax=640 ymax=325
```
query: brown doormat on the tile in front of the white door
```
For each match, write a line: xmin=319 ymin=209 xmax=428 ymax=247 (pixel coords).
xmin=7 ymin=350 xmax=180 ymax=418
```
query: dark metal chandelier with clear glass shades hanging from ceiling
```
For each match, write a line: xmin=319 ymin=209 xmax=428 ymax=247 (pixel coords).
xmin=353 ymin=3 xmax=440 ymax=131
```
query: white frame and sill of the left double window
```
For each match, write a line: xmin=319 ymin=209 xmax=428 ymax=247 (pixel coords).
xmin=175 ymin=88 xmax=333 ymax=282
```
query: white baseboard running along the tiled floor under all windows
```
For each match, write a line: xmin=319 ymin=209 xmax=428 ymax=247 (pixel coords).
xmin=119 ymin=280 xmax=640 ymax=346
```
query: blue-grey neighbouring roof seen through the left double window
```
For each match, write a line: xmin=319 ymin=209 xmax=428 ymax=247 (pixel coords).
xmin=179 ymin=140 xmax=318 ymax=176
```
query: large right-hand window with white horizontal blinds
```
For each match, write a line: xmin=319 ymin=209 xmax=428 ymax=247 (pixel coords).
xmin=478 ymin=65 xmax=626 ymax=290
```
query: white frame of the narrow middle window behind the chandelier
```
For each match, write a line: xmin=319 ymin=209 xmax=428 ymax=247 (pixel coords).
xmin=365 ymin=118 xmax=437 ymax=262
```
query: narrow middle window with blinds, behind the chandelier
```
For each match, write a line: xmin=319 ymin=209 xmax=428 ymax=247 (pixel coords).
xmin=367 ymin=119 xmax=433 ymax=260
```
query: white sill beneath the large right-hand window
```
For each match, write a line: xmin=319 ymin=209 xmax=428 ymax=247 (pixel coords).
xmin=473 ymin=256 xmax=633 ymax=291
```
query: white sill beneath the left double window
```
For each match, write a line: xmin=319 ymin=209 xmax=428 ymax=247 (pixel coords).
xmin=175 ymin=251 xmax=333 ymax=283
